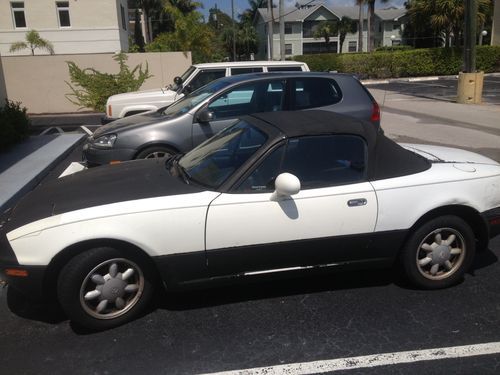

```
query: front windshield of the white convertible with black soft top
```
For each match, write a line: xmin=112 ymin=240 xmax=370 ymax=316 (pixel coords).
xmin=178 ymin=120 xmax=267 ymax=189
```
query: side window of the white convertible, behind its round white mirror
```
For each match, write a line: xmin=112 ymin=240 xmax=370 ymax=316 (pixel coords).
xmin=237 ymin=135 xmax=367 ymax=193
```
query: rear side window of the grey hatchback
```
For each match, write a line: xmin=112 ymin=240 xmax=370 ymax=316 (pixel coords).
xmin=291 ymin=77 xmax=342 ymax=110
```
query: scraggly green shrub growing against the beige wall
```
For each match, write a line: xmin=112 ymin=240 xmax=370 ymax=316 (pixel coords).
xmin=66 ymin=53 xmax=151 ymax=112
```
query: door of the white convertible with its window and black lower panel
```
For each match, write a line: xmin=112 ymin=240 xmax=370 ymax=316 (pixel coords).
xmin=206 ymin=135 xmax=377 ymax=276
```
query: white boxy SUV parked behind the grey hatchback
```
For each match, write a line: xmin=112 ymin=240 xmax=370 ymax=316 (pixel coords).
xmin=102 ymin=61 xmax=309 ymax=124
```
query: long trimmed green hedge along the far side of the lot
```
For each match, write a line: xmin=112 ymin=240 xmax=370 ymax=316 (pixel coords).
xmin=294 ymin=46 xmax=500 ymax=78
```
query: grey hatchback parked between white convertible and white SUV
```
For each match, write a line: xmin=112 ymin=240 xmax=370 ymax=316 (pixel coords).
xmin=83 ymin=72 xmax=380 ymax=166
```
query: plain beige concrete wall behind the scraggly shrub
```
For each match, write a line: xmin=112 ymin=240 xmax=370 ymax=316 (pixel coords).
xmin=0 ymin=52 xmax=191 ymax=113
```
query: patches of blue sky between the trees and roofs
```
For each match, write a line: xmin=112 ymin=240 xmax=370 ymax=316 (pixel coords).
xmin=198 ymin=0 xmax=405 ymax=20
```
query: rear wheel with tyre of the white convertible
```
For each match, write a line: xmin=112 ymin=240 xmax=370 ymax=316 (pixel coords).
xmin=400 ymin=215 xmax=475 ymax=289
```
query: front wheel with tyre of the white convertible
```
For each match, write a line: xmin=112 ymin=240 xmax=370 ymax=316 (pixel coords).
xmin=57 ymin=247 xmax=153 ymax=330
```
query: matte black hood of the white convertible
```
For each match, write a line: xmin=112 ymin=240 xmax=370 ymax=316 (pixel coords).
xmin=2 ymin=159 xmax=205 ymax=232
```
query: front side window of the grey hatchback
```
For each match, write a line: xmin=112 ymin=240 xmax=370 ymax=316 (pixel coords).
xmin=208 ymin=80 xmax=285 ymax=119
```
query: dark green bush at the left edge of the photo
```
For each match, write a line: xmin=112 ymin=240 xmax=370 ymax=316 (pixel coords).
xmin=0 ymin=99 xmax=31 ymax=151
